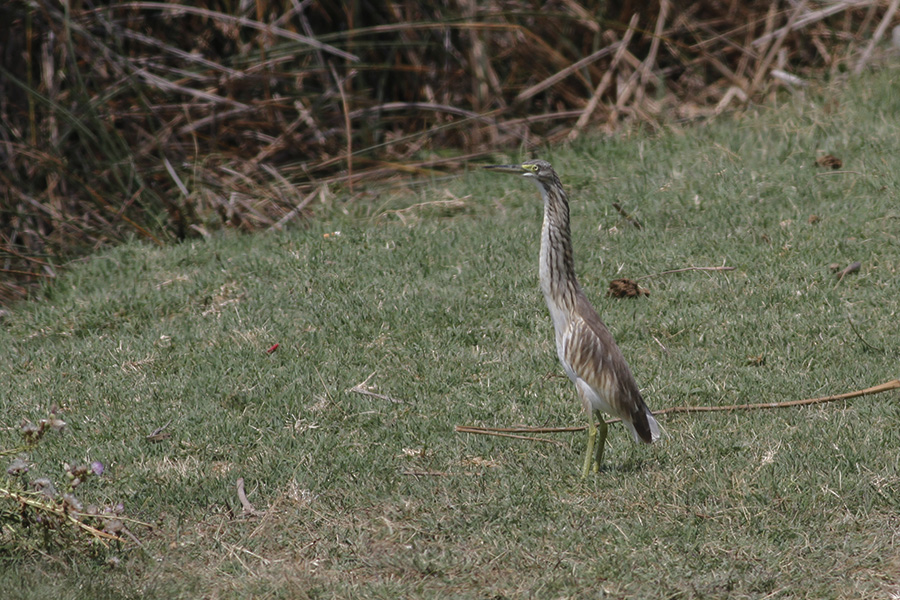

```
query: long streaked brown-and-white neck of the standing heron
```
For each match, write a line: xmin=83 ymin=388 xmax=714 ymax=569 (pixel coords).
xmin=539 ymin=180 xmax=580 ymax=312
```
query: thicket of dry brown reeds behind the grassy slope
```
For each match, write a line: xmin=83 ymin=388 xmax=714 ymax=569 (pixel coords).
xmin=0 ymin=0 xmax=900 ymax=302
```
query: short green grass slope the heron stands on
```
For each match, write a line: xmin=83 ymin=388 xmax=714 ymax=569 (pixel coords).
xmin=0 ymin=71 xmax=900 ymax=599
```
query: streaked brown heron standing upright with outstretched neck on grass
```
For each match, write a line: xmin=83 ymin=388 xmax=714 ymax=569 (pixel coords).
xmin=484 ymin=160 xmax=660 ymax=478
